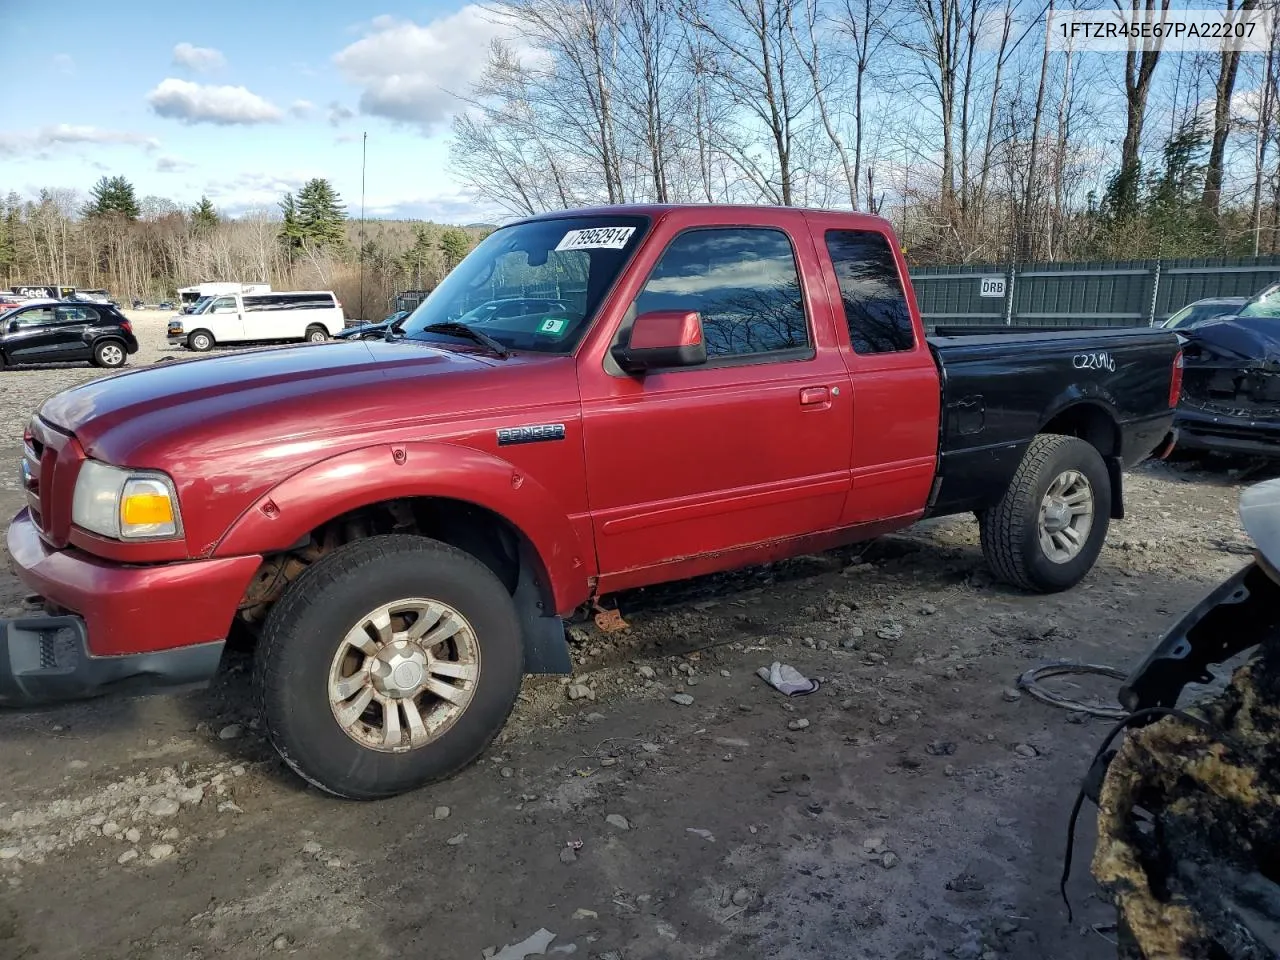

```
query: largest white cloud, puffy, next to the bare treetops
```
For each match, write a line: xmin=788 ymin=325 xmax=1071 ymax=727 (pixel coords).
xmin=333 ymin=4 xmax=502 ymax=133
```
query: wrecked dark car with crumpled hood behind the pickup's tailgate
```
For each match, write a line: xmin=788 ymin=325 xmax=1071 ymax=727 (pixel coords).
xmin=1174 ymin=283 xmax=1280 ymax=460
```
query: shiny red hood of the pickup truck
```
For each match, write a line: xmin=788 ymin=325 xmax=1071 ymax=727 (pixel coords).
xmin=40 ymin=340 xmax=576 ymax=470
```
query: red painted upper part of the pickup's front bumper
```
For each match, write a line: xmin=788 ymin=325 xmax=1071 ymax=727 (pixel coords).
xmin=8 ymin=511 xmax=261 ymax=657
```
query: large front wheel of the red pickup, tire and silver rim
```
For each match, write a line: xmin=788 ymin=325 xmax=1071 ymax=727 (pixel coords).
xmin=255 ymin=535 xmax=525 ymax=800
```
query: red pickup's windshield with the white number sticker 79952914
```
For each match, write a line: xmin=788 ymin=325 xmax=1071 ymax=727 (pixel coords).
xmin=401 ymin=216 xmax=649 ymax=353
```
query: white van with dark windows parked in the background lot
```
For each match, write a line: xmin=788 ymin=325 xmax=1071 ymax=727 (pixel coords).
xmin=169 ymin=291 xmax=343 ymax=352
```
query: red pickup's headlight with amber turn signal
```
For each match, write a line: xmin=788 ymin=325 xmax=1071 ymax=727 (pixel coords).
xmin=72 ymin=460 xmax=182 ymax=540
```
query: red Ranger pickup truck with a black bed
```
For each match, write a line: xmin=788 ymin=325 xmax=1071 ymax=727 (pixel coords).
xmin=0 ymin=206 xmax=1180 ymax=799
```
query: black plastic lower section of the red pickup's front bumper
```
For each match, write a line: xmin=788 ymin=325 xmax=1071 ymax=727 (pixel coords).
xmin=0 ymin=616 xmax=225 ymax=707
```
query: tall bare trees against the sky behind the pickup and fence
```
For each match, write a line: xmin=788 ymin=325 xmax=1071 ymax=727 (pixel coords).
xmin=452 ymin=0 xmax=1280 ymax=264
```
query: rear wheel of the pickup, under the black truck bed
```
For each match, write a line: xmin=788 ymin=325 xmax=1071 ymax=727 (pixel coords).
xmin=978 ymin=434 xmax=1111 ymax=593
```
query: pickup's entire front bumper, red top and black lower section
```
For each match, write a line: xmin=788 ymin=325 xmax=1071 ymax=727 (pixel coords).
xmin=0 ymin=511 xmax=261 ymax=703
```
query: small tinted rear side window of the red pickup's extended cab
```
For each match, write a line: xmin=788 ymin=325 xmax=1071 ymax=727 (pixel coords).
xmin=823 ymin=230 xmax=915 ymax=356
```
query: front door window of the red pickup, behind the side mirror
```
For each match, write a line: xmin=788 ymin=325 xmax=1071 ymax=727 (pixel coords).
xmin=635 ymin=227 xmax=813 ymax=365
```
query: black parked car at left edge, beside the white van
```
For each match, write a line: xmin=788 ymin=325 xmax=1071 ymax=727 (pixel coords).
xmin=0 ymin=300 xmax=138 ymax=367
